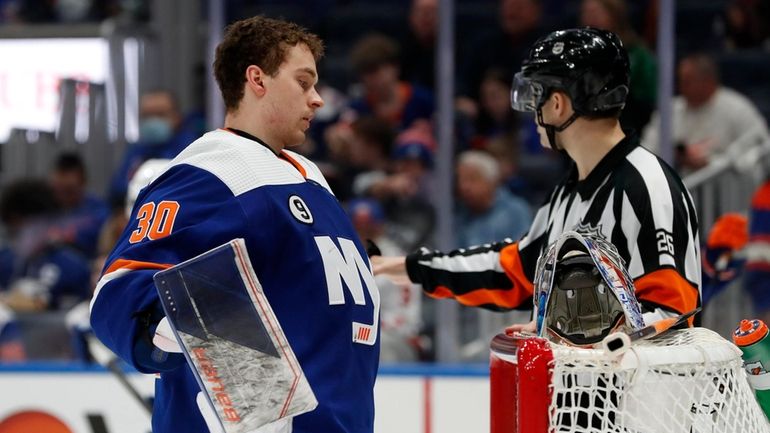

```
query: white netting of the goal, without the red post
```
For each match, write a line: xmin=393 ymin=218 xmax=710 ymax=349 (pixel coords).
xmin=549 ymin=328 xmax=770 ymax=433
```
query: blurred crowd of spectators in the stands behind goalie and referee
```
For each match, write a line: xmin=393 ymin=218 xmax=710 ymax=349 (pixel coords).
xmin=0 ymin=0 xmax=770 ymax=361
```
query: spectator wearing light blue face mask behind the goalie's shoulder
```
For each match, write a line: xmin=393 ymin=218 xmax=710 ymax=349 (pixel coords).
xmin=110 ymin=90 xmax=201 ymax=203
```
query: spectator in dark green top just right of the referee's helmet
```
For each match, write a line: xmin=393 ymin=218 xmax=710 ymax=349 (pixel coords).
xmin=580 ymin=0 xmax=657 ymax=131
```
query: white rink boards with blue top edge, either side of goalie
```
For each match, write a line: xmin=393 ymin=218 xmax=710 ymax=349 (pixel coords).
xmin=0 ymin=363 xmax=489 ymax=433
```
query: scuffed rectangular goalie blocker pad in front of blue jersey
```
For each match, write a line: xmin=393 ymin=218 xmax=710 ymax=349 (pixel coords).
xmin=154 ymin=239 xmax=318 ymax=433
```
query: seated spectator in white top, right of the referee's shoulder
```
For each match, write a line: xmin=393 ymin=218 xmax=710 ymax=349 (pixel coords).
xmin=642 ymin=54 xmax=767 ymax=172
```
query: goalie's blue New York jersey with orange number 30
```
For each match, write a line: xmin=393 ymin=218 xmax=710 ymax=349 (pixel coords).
xmin=91 ymin=129 xmax=380 ymax=433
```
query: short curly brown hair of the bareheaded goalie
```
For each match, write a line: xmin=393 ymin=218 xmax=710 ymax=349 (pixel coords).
xmin=214 ymin=15 xmax=324 ymax=111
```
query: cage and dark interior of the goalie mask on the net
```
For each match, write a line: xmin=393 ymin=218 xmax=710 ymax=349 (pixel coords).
xmin=545 ymin=253 xmax=625 ymax=346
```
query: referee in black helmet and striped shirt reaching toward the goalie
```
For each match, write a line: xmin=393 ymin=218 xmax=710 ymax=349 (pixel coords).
xmin=372 ymin=27 xmax=701 ymax=330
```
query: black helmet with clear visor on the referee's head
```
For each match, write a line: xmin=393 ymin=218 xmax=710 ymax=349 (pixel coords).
xmin=511 ymin=27 xmax=629 ymax=115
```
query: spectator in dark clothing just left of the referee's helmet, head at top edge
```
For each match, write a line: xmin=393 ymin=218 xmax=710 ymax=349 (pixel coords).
xmin=457 ymin=0 xmax=547 ymax=118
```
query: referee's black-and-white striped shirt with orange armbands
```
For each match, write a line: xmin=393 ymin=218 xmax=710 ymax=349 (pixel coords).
xmin=406 ymin=135 xmax=701 ymax=313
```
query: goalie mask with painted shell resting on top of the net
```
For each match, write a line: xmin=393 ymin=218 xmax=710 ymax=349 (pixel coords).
xmin=535 ymin=232 xmax=644 ymax=346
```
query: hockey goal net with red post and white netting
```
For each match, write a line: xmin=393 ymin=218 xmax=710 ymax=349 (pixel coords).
xmin=490 ymin=328 xmax=770 ymax=433
